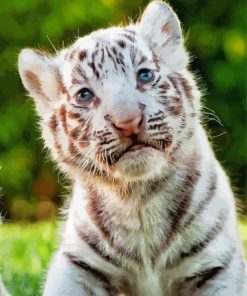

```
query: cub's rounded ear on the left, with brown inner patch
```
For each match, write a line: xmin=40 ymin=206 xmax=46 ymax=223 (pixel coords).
xmin=18 ymin=49 xmax=65 ymax=116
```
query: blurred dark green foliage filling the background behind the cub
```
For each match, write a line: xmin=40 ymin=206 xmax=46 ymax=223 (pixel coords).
xmin=0 ymin=0 xmax=246 ymax=220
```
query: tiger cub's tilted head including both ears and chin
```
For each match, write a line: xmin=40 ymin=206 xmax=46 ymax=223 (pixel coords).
xmin=19 ymin=1 xmax=199 ymax=182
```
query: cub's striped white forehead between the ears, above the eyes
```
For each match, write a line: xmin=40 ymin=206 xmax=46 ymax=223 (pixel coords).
xmin=63 ymin=28 xmax=153 ymax=83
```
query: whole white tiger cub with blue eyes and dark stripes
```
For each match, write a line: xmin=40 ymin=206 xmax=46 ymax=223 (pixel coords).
xmin=19 ymin=1 xmax=247 ymax=296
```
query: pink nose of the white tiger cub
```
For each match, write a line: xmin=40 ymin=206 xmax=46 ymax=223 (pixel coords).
xmin=111 ymin=115 xmax=143 ymax=137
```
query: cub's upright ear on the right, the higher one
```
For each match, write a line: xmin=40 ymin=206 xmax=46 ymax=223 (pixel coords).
xmin=139 ymin=1 xmax=189 ymax=71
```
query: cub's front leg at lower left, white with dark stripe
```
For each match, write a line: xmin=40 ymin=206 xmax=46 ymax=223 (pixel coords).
xmin=43 ymin=250 xmax=116 ymax=296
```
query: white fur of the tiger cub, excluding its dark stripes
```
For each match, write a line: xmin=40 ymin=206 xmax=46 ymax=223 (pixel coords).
xmin=19 ymin=1 xmax=246 ymax=296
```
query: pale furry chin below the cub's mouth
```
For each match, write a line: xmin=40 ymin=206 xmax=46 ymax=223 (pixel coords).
xmin=112 ymin=147 xmax=167 ymax=182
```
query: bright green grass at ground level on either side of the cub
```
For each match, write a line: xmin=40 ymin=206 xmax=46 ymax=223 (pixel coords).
xmin=0 ymin=219 xmax=247 ymax=296
